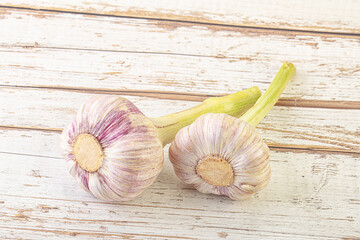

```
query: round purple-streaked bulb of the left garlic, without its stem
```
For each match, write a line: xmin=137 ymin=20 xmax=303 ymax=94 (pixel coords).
xmin=62 ymin=96 xmax=164 ymax=201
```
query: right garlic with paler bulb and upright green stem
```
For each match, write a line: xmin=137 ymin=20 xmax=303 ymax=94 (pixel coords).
xmin=169 ymin=62 xmax=296 ymax=200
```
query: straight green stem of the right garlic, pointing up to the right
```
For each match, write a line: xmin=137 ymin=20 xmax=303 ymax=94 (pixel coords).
xmin=240 ymin=62 xmax=296 ymax=127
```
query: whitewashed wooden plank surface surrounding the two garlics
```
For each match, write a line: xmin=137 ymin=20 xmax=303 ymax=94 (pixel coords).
xmin=0 ymin=0 xmax=360 ymax=240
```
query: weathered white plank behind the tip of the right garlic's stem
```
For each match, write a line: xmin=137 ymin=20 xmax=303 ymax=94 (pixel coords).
xmin=0 ymin=48 xmax=360 ymax=101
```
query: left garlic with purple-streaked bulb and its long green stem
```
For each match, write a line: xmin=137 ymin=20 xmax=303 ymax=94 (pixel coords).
xmin=62 ymin=87 xmax=261 ymax=201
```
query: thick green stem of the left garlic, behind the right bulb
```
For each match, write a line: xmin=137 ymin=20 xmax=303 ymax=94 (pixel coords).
xmin=151 ymin=87 xmax=261 ymax=146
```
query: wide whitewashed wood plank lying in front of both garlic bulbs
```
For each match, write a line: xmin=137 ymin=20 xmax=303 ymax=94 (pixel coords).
xmin=0 ymin=147 xmax=360 ymax=239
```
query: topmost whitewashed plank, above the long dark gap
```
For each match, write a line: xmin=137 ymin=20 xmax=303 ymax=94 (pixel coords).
xmin=1 ymin=0 xmax=360 ymax=33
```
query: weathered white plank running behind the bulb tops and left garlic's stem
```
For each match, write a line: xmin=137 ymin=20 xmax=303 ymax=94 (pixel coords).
xmin=0 ymin=88 xmax=360 ymax=153
